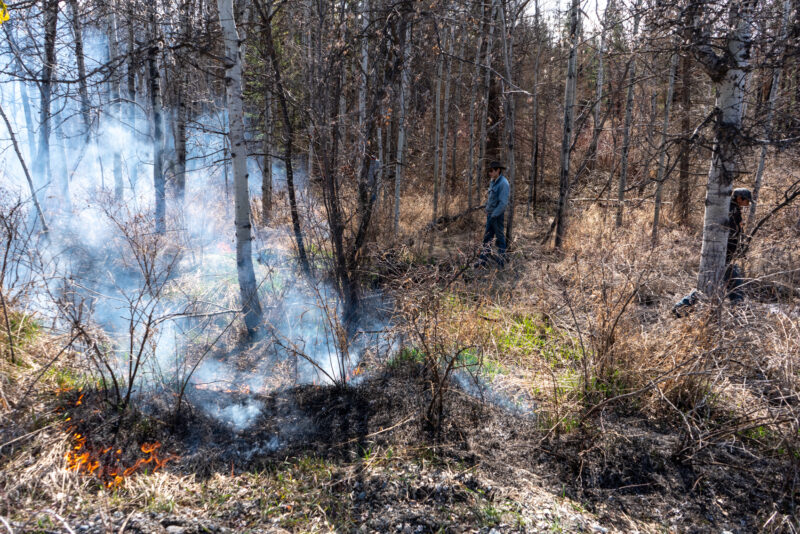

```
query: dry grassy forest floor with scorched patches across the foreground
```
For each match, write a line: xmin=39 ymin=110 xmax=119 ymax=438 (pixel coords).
xmin=0 ymin=200 xmax=800 ymax=534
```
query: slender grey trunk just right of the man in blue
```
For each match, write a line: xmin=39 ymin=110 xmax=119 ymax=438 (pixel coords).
xmin=553 ymin=0 xmax=580 ymax=250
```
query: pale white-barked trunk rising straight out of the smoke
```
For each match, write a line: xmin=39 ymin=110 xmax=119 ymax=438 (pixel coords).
xmin=217 ymin=0 xmax=261 ymax=332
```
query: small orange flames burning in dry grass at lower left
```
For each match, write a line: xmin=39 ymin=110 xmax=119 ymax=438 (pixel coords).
xmin=64 ymin=433 xmax=178 ymax=488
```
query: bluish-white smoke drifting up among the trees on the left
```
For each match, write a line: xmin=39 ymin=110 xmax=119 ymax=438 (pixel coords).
xmin=0 ymin=23 xmax=392 ymax=436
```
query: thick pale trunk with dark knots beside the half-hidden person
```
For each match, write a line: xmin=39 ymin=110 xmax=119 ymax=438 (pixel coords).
xmin=694 ymin=1 xmax=753 ymax=294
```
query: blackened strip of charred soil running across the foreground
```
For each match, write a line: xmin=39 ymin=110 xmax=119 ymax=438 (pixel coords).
xmin=65 ymin=367 xmax=797 ymax=533
